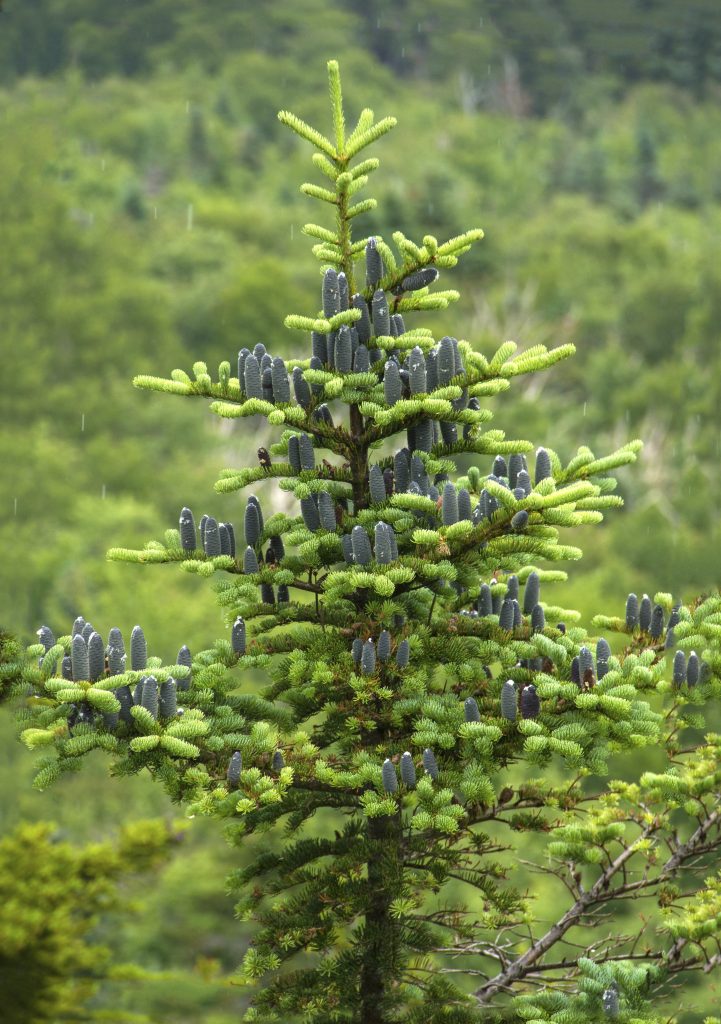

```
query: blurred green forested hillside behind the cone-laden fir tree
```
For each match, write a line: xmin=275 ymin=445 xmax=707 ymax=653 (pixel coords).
xmin=0 ymin=0 xmax=721 ymax=1024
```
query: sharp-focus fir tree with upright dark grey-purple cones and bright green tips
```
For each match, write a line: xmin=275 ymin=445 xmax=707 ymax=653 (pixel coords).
xmin=8 ymin=61 xmax=721 ymax=1024
